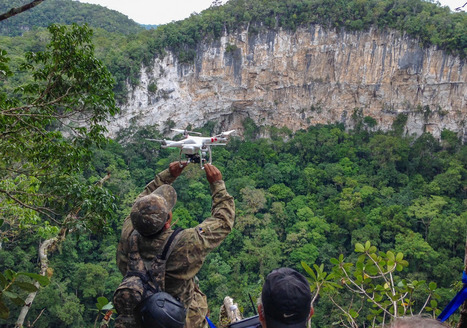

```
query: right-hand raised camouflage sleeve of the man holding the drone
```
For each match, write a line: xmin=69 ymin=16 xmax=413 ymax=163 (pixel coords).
xmin=167 ymin=180 xmax=235 ymax=280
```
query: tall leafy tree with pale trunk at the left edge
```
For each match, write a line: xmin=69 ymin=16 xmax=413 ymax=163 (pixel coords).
xmin=0 ymin=24 xmax=117 ymax=327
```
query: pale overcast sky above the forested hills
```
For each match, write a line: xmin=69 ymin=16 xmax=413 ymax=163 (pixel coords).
xmin=78 ymin=0 xmax=467 ymax=25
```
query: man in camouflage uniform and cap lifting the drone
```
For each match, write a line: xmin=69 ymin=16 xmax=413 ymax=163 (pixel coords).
xmin=116 ymin=162 xmax=235 ymax=328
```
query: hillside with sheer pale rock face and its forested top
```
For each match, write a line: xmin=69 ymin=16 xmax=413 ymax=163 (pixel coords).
xmin=110 ymin=0 xmax=467 ymax=140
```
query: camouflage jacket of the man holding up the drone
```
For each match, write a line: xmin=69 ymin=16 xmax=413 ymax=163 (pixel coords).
xmin=117 ymin=169 xmax=235 ymax=328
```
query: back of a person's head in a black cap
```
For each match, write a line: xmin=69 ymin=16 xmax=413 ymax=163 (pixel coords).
xmin=258 ymin=268 xmax=314 ymax=328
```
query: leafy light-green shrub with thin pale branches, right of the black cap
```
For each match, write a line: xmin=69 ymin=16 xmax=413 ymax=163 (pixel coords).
xmin=301 ymin=241 xmax=441 ymax=328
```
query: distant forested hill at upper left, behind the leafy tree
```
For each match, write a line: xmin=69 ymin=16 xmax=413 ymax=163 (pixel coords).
xmin=0 ymin=0 xmax=144 ymax=36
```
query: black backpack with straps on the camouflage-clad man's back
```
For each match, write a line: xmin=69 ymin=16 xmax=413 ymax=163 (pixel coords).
xmin=113 ymin=228 xmax=186 ymax=328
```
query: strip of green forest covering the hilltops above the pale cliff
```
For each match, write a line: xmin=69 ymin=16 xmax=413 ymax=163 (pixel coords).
xmin=0 ymin=0 xmax=467 ymax=103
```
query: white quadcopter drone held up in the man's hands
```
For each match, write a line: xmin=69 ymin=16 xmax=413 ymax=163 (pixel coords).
xmin=146 ymin=129 xmax=235 ymax=169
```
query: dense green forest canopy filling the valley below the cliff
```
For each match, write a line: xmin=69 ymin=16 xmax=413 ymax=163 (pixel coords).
xmin=0 ymin=114 xmax=467 ymax=327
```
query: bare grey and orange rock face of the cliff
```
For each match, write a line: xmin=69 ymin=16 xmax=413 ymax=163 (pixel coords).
xmin=109 ymin=25 xmax=467 ymax=137
